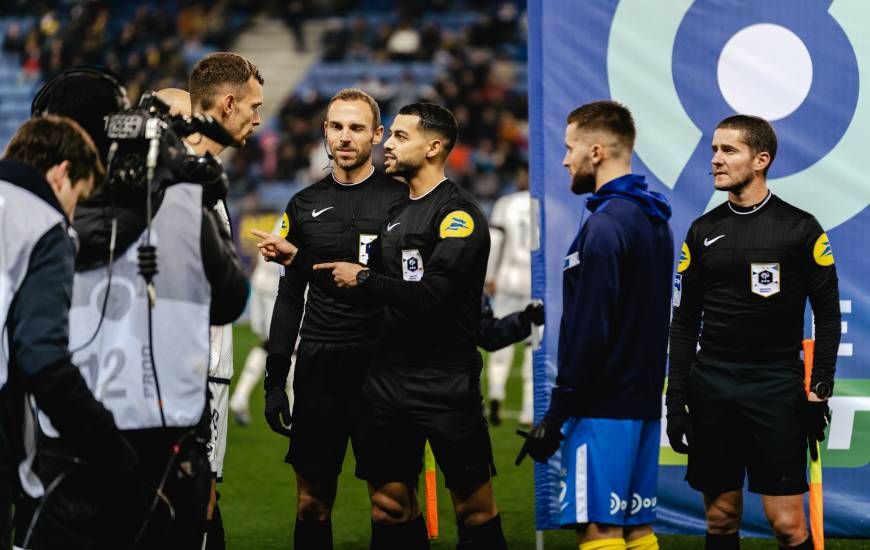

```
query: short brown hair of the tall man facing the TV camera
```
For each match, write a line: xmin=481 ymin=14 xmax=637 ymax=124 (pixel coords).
xmin=189 ymin=52 xmax=265 ymax=110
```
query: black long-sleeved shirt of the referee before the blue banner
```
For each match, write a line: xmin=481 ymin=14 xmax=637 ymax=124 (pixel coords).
xmin=668 ymin=195 xmax=840 ymax=402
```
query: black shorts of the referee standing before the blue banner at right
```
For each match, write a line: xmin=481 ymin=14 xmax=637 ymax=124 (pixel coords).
xmin=686 ymin=354 xmax=809 ymax=496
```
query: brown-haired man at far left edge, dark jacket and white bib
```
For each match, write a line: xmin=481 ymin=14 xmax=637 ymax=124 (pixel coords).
xmin=0 ymin=116 xmax=132 ymax=549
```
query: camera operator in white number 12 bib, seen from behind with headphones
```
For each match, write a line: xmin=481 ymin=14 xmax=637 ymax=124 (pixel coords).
xmin=17 ymin=64 xmax=248 ymax=548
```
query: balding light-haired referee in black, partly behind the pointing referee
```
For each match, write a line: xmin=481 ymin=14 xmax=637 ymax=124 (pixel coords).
xmin=258 ymin=89 xmax=408 ymax=550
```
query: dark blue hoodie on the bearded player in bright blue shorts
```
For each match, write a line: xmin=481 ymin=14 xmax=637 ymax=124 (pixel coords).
xmin=547 ymin=174 xmax=674 ymax=422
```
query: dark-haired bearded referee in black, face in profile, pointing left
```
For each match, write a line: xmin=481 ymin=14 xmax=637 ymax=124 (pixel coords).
xmin=315 ymin=103 xmax=506 ymax=550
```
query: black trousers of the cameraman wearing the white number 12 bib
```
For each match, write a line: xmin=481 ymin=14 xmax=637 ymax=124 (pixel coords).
xmin=15 ymin=427 xmax=211 ymax=550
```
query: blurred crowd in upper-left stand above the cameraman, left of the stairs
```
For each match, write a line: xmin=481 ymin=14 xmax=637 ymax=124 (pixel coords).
xmin=4 ymin=0 xmax=247 ymax=104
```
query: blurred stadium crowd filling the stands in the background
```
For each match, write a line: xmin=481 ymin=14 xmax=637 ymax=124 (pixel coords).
xmin=3 ymin=0 xmax=528 ymax=209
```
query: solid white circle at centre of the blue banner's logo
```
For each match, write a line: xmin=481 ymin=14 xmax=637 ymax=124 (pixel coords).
xmin=717 ymin=23 xmax=813 ymax=120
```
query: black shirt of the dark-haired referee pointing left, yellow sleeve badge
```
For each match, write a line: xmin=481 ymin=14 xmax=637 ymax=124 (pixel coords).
xmin=361 ymin=179 xmax=489 ymax=366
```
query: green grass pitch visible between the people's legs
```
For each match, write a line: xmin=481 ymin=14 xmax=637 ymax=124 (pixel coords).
xmin=219 ymin=326 xmax=870 ymax=550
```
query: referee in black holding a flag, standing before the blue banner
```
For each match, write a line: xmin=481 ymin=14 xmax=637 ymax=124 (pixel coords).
xmin=667 ymin=115 xmax=840 ymax=549
